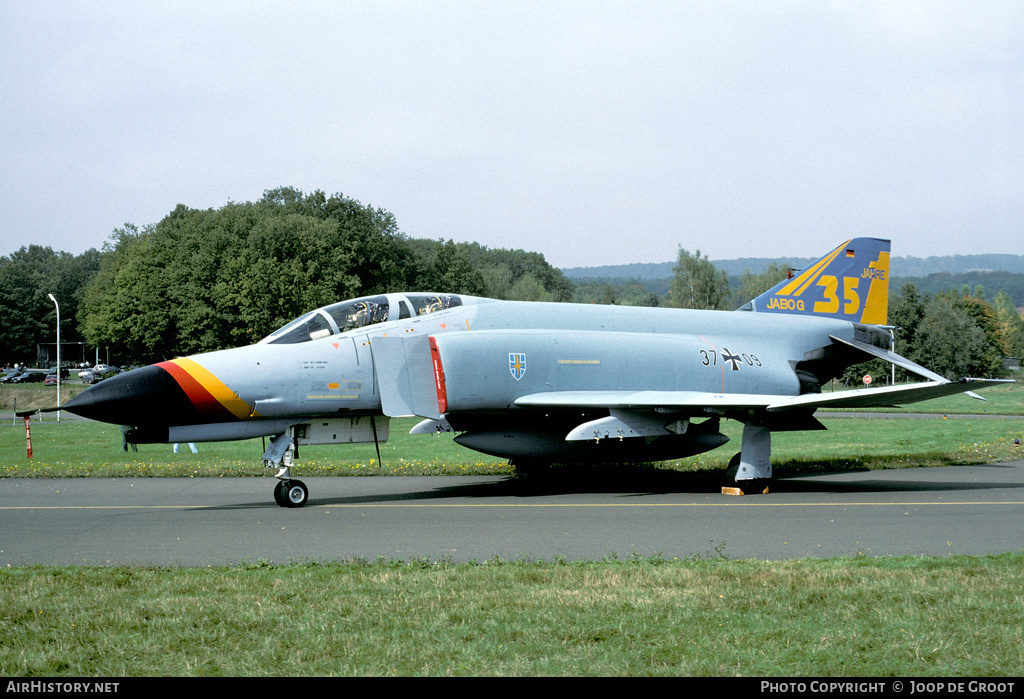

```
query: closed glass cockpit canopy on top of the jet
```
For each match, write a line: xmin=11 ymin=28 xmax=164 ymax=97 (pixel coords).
xmin=261 ymin=294 xmax=463 ymax=345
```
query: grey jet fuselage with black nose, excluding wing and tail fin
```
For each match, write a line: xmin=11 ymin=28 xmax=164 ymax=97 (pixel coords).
xmin=65 ymin=294 xmax=881 ymax=448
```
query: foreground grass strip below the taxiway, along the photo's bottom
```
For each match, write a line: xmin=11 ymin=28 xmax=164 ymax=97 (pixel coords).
xmin=0 ymin=554 xmax=1024 ymax=678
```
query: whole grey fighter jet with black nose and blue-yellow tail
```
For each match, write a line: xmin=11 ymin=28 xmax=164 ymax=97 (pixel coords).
xmin=56 ymin=238 xmax=998 ymax=507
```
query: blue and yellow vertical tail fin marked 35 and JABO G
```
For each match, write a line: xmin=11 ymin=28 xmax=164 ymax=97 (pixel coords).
xmin=741 ymin=237 xmax=889 ymax=325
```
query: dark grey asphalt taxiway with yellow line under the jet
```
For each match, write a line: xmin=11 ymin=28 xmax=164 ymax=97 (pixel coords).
xmin=0 ymin=461 xmax=1024 ymax=566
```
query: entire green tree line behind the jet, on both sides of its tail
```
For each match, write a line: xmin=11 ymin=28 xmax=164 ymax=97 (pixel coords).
xmin=0 ymin=187 xmax=1024 ymax=378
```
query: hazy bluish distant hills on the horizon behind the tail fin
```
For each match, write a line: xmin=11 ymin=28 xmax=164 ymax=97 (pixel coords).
xmin=562 ymin=255 xmax=1024 ymax=280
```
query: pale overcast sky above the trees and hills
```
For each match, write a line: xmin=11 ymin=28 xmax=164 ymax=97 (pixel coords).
xmin=0 ymin=0 xmax=1024 ymax=267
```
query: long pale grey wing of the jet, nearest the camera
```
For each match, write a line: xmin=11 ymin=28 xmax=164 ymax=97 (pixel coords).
xmin=515 ymin=379 xmax=1013 ymax=413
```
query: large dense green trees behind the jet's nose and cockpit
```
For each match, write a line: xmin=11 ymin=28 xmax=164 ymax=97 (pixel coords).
xmin=0 ymin=187 xmax=574 ymax=363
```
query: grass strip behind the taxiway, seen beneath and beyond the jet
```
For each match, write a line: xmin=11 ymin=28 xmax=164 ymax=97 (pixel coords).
xmin=0 ymin=387 xmax=1024 ymax=478
